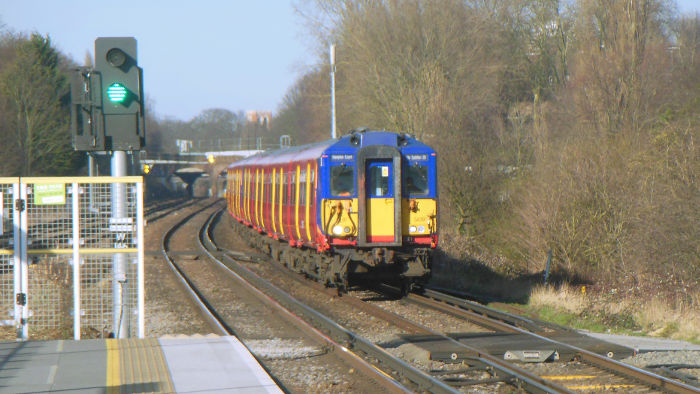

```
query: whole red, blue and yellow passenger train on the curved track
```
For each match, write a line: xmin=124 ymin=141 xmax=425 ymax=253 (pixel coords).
xmin=225 ymin=128 xmax=438 ymax=292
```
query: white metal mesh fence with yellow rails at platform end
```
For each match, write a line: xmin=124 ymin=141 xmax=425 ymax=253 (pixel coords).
xmin=0 ymin=177 xmax=144 ymax=339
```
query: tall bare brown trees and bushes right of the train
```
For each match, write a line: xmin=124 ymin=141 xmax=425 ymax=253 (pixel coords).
xmin=272 ymin=0 xmax=700 ymax=339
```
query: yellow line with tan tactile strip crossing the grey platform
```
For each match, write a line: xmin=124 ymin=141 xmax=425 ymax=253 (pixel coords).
xmin=107 ymin=338 xmax=175 ymax=393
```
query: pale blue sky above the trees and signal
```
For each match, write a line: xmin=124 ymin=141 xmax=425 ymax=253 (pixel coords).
xmin=0 ymin=0 xmax=700 ymax=120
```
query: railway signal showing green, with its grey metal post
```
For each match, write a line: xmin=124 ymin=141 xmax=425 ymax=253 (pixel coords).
xmin=71 ymin=37 xmax=146 ymax=338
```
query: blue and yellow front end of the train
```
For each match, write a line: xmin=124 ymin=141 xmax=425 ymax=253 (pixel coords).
xmin=319 ymin=133 xmax=437 ymax=284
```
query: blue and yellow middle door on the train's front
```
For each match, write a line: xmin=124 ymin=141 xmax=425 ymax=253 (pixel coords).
xmin=365 ymin=159 xmax=396 ymax=243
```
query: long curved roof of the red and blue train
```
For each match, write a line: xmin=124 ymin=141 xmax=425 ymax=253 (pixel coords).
xmin=229 ymin=129 xmax=434 ymax=168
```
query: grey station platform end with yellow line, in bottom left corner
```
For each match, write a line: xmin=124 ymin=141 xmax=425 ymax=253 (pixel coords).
xmin=0 ymin=336 xmax=282 ymax=394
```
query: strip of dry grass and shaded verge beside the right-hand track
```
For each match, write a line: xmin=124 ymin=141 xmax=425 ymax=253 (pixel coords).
xmin=431 ymin=235 xmax=700 ymax=344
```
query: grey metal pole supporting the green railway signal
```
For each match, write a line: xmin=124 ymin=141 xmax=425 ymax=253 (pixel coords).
xmin=112 ymin=151 xmax=129 ymax=338
